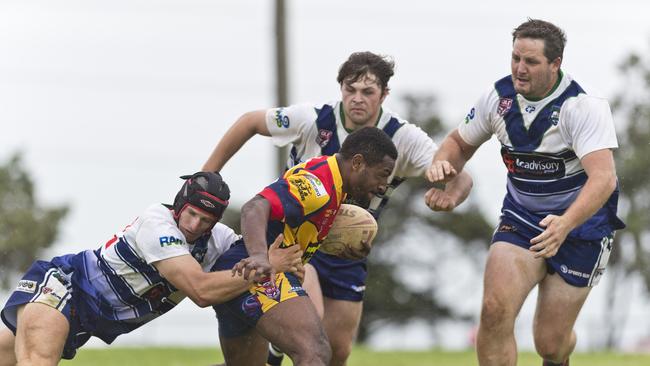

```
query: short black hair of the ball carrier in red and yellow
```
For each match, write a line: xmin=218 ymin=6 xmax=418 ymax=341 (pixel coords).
xmin=339 ymin=127 xmax=397 ymax=165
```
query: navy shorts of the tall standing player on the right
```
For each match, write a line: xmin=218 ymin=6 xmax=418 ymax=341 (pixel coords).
xmin=492 ymin=216 xmax=614 ymax=287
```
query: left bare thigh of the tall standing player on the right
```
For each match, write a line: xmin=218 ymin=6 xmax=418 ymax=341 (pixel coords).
xmin=483 ymin=242 xmax=546 ymax=320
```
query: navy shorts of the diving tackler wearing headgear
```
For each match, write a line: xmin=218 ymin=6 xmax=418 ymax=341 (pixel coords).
xmin=1 ymin=261 xmax=90 ymax=360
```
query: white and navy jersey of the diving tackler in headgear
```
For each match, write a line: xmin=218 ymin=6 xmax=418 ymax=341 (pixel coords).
xmin=53 ymin=204 xmax=239 ymax=326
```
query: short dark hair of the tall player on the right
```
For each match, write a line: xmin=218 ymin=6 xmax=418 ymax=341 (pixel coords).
xmin=512 ymin=18 xmax=566 ymax=62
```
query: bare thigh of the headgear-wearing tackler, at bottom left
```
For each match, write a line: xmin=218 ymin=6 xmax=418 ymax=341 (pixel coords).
xmin=16 ymin=303 xmax=70 ymax=365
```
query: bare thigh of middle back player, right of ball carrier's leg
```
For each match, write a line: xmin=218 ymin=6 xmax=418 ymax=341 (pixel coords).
xmin=323 ymin=297 xmax=363 ymax=349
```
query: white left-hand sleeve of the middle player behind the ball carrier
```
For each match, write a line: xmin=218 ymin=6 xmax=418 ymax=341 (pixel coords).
xmin=266 ymin=104 xmax=317 ymax=146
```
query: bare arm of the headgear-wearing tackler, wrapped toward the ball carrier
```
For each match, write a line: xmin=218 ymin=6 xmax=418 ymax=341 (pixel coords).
xmin=153 ymin=254 xmax=250 ymax=307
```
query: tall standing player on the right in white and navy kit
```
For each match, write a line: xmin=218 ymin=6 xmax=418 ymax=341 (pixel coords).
xmin=427 ymin=19 xmax=625 ymax=366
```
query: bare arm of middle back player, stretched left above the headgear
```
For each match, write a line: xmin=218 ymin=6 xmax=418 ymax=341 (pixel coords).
xmin=202 ymin=110 xmax=271 ymax=172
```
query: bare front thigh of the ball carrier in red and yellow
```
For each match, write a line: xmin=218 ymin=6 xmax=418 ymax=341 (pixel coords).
xmin=256 ymin=296 xmax=327 ymax=355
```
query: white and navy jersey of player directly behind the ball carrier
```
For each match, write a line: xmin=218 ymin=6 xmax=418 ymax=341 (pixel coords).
xmin=266 ymin=102 xmax=438 ymax=217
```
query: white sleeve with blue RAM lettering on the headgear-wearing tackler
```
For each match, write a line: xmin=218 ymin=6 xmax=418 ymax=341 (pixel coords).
xmin=132 ymin=218 xmax=190 ymax=264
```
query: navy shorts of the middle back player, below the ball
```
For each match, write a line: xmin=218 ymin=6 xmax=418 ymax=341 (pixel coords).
xmin=309 ymin=250 xmax=368 ymax=302
